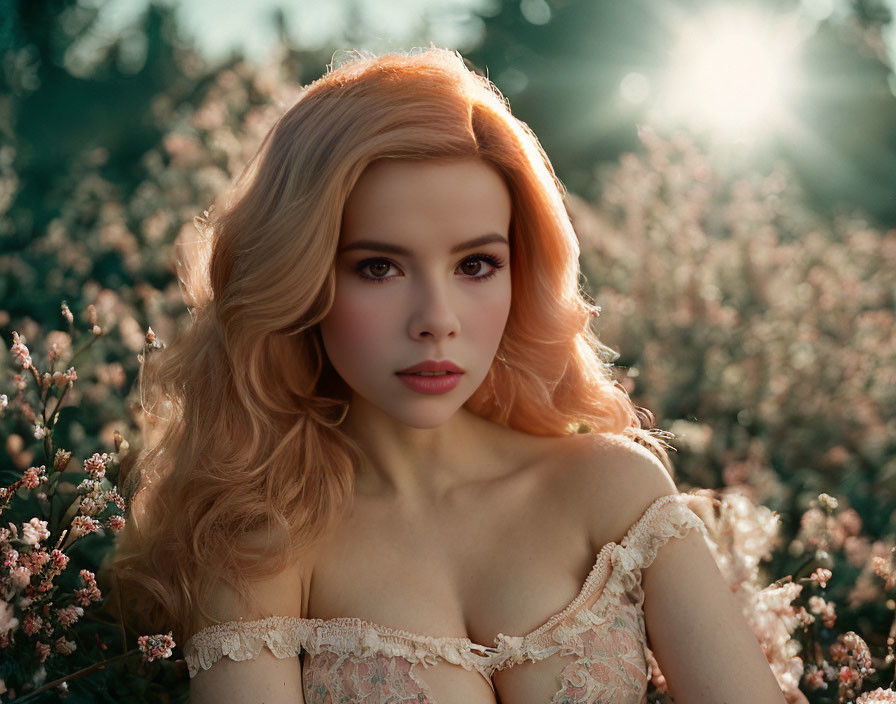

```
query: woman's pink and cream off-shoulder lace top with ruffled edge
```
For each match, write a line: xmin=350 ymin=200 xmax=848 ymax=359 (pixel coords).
xmin=184 ymin=494 xmax=706 ymax=704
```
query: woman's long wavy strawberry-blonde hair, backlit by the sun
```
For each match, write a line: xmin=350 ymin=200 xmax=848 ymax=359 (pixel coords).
xmin=103 ymin=46 xmax=672 ymax=642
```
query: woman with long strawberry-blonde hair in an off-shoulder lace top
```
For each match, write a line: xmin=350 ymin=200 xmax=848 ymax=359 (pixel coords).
xmin=110 ymin=48 xmax=784 ymax=704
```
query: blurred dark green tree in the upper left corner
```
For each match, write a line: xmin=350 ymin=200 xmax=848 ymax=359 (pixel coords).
xmin=2 ymin=0 xmax=194 ymax=250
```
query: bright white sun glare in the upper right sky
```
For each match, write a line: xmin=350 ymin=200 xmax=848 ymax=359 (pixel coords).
xmin=658 ymin=7 xmax=801 ymax=138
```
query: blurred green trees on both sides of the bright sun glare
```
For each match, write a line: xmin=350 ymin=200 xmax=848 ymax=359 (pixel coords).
xmin=466 ymin=0 xmax=896 ymax=225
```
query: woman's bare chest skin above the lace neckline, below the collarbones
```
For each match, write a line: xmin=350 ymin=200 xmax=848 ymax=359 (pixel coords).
xmin=303 ymin=456 xmax=595 ymax=646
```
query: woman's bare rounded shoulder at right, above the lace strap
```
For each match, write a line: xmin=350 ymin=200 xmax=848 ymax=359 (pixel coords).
xmin=561 ymin=433 xmax=679 ymax=551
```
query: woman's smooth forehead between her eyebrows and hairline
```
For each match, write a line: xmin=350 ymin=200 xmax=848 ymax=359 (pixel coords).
xmin=341 ymin=159 xmax=511 ymax=244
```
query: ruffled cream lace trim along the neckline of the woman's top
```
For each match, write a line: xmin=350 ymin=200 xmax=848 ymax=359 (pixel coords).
xmin=184 ymin=494 xmax=706 ymax=680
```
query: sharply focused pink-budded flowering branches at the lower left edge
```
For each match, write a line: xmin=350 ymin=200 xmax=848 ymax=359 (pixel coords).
xmin=0 ymin=310 xmax=174 ymax=702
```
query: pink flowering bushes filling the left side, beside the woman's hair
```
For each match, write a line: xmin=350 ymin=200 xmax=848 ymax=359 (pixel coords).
xmin=0 ymin=41 xmax=298 ymax=702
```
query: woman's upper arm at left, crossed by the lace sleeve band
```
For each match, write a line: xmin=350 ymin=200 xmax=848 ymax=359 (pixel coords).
xmin=190 ymin=556 xmax=304 ymax=704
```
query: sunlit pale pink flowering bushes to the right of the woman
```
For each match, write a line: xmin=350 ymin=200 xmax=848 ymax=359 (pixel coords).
xmin=569 ymin=127 xmax=896 ymax=702
